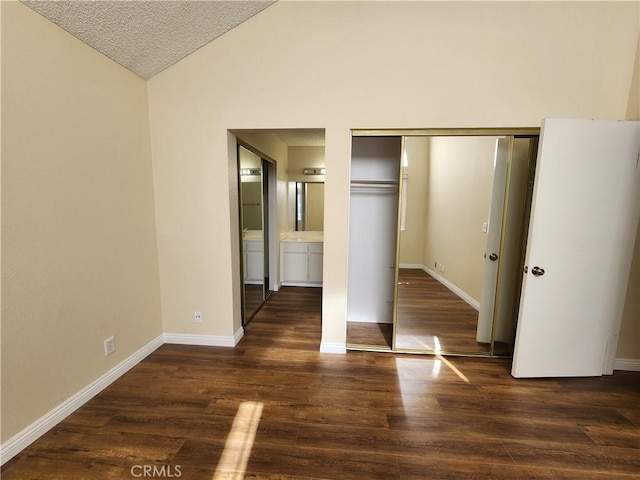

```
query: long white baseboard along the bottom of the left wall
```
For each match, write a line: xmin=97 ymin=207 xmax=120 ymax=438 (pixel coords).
xmin=0 ymin=335 xmax=163 ymax=465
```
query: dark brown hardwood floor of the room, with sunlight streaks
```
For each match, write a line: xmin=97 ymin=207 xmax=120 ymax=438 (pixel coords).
xmin=2 ymin=287 xmax=640 ymax=480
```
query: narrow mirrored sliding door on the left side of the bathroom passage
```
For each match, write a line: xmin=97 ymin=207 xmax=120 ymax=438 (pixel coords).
xmin=238 ymin=146 xmax=265 ymax=323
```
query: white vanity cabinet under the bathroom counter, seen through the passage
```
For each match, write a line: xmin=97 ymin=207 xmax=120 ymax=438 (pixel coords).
xmin=280 ymin=241 xmax=323 ymax=287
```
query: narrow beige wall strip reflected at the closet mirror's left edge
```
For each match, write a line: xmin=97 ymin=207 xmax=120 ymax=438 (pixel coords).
xmin=399 ymin=137 xmax=429 ymax=267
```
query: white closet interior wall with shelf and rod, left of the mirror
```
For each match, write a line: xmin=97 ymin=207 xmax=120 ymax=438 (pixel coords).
xmin=347 ymin=137 xmax=402 ymax=323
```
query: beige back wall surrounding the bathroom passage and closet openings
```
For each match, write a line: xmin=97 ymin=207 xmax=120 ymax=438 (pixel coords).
xmin=149 ymin=2 xmax=638 ymax=352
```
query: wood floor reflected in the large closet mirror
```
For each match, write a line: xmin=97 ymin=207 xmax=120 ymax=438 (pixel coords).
xmin=396 ymin=268 xmax=500 ymax=355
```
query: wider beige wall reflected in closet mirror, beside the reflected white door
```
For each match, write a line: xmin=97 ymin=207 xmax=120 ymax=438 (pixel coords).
xmin=423 ymin=137 xmax=496 ymax=302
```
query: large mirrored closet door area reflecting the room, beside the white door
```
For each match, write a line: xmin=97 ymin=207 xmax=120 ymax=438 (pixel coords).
xmin=394 ymin=136 xmax=531 ymax=355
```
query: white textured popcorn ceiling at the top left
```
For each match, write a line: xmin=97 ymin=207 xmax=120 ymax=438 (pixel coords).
xmin=22 ymin=0 xmax=275 ymax=79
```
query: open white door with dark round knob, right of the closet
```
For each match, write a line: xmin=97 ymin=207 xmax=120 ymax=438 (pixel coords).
xmin=512 ymin=119 xmax=640 ymax=377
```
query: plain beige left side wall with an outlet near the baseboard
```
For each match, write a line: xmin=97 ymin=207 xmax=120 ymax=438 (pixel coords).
xmin=1 ymin=2 xmax=162 ymax=442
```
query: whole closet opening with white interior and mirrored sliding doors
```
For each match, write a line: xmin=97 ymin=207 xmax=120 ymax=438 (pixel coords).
xmin=347 ymin=129 xmax=538 ymax=356
